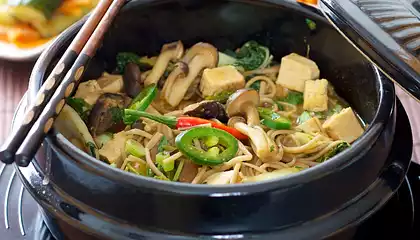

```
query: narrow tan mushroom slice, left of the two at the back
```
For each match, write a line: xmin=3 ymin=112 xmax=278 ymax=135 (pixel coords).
xmin=144 ymin=41 xmax=184 ymax=86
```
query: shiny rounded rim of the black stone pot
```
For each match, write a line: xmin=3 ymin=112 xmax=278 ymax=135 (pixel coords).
xmin=28 ymin=0 xmax=395 ymax=197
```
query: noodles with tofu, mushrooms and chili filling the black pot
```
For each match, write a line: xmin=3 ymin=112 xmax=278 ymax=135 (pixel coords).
xmin=56 ymin=41 xmax=365 ymax=185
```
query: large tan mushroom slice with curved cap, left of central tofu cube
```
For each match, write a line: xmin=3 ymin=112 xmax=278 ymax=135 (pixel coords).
xmin=164 ymin=43 xmax=218 ymax=107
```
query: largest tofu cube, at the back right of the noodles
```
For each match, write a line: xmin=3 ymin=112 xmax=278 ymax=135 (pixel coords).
xmin=276 ymin=53 xmax=319 ymax=92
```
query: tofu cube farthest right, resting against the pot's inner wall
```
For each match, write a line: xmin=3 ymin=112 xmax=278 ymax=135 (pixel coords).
xmin=322 ymin=108 xmax=364 ymax=143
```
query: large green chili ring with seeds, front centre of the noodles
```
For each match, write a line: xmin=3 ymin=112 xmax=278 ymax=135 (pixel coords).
xmin=175 ymin=127 xmax=238 ymax=166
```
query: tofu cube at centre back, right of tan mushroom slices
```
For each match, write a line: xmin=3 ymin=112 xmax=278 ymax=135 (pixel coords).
xmin=200 ymin=66 xmax=245 ymax=97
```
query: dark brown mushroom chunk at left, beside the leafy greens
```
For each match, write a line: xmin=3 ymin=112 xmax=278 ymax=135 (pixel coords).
xmin=88 ymin=93 xmax=127 ymax=136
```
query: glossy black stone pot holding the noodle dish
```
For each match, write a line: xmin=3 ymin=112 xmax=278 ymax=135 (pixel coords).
xmin=18 ymin=0 xmax=412 ymax=239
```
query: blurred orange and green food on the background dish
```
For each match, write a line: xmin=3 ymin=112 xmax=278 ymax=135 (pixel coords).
xmin=0 ymin=0 xmax=98 ymax=48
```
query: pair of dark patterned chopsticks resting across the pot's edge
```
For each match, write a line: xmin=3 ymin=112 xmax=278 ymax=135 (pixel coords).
xmin=0 ymin=0 xmax=125 ymax=167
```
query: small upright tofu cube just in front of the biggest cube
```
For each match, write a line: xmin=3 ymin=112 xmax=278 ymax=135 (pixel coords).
xmin=303 ymin=79 xmax=328 ymax=112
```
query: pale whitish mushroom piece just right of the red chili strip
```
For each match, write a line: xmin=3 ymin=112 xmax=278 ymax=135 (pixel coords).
xmin=235 ymin=122 xmax=283 ymax=162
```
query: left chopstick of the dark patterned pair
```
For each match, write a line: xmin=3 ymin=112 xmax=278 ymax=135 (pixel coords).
xmin=0 ymin=0 xmax=112 ymax=164
